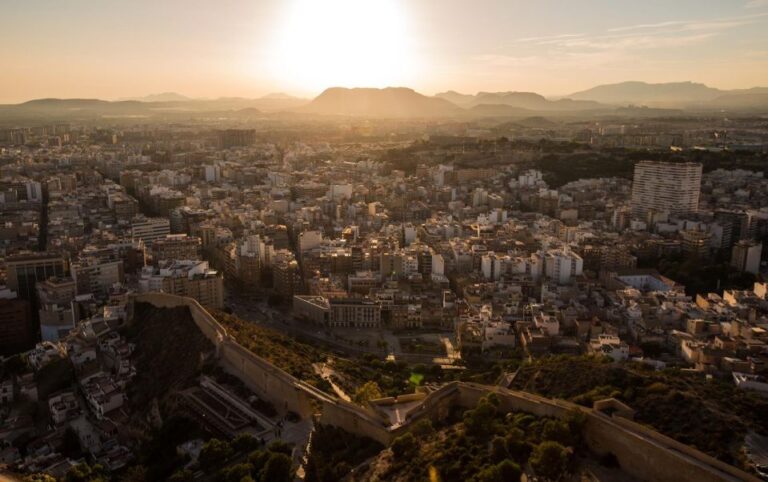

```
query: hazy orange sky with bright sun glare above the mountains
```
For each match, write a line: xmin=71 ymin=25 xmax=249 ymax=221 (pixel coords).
xmin=0 ymin=0 xmax=768 ymax=102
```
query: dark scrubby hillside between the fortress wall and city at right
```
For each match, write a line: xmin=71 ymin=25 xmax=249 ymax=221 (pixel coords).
xmin=511 ymin=357 xmax=768 ymax=466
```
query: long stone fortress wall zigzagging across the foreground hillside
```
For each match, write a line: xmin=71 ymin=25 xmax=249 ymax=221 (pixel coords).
xmin=132 ymin=293 xmax=759 ymax=482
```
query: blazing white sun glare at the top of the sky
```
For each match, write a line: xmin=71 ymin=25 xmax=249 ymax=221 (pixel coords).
xmin=268 ymin=0 xmax=417 ymax=92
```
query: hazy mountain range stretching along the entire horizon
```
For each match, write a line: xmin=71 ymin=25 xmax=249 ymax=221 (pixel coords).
xmin=0 ymin=81 xmax=768 ymax=119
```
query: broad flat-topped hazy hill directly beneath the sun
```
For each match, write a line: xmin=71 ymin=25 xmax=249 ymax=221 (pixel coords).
xmin=300 ymin=87 xmax=461 ymax=118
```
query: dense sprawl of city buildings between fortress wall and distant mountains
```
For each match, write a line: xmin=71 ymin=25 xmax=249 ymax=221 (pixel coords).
xmin=0 ymin=107 xmax=768 ymax=477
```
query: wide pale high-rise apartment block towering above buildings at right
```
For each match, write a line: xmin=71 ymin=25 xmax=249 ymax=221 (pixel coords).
xmin=632 ymin=161 xmax=701 ymax=219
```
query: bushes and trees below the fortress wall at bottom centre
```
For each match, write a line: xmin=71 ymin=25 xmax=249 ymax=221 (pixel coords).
xmin=355 ymin=394 xmax=584 ymax=482
